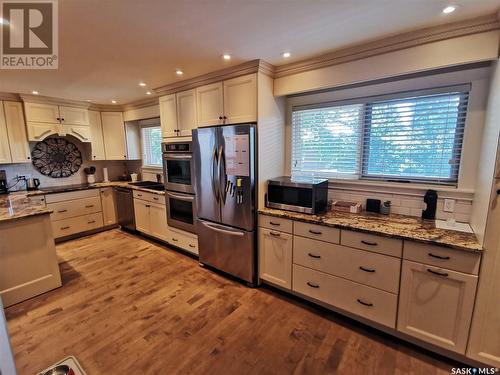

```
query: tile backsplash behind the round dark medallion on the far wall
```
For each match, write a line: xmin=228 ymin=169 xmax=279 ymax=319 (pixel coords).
xmin=0 ymin=139 xmax=142 ymax=191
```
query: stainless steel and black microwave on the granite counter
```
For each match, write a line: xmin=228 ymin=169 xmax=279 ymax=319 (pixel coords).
xmin=266 ymin=176 xmax=328 ymax=214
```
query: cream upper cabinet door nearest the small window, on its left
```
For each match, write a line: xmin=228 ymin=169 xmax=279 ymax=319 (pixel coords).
xmin=101 ymin=112 xmax=127 ymax=160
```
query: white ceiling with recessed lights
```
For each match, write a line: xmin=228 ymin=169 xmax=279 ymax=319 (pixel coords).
xmin=0 ymin=0 xmax=500 ymax=104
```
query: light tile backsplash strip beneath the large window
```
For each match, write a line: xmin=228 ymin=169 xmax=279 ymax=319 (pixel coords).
xmin=328 ymin=188 xmax=472 ymax=223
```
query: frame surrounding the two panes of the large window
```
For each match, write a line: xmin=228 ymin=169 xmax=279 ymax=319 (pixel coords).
xmin=290 ymin=83 xmax=472 ymax=187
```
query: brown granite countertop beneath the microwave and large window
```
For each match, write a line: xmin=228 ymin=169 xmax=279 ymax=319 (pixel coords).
xmin=259 ymin=208 xmax=483 ymax=252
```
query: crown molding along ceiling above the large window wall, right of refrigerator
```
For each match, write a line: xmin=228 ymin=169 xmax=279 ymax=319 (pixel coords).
xmin=274 ymin=13 xmax=500 ymax=78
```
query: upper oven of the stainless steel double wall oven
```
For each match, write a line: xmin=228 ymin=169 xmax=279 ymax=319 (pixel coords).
xmin=161 ymin=141 xmax=194 ymax=194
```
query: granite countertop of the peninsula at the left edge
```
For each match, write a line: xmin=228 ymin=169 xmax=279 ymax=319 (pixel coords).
xmin=0 ymin=192 xmax=52 ymax=222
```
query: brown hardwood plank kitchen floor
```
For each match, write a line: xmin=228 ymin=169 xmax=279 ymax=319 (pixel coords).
xmin=6 ymin=230 xmax=455 ymax=375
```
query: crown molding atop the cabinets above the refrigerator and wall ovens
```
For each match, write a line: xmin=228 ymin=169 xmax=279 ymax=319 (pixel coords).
xmin=153 ymin=59 xmax=275 ymax=96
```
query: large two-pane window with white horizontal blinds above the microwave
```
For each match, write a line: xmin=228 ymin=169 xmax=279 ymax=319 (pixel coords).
xmin=292 ymin=90 xmax=468 ymax=184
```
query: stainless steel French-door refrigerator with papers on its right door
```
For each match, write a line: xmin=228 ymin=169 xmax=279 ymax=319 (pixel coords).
xmin=193 ymin=124 xmax=256 ymax=284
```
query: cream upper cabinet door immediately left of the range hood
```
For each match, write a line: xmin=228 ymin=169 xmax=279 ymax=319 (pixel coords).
xmin=3 ymin=101 xmax=31 ymax=163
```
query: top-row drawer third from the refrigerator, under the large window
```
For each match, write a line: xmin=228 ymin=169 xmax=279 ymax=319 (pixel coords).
xmin=340 ymin=230 xmax=403 ymax=258
